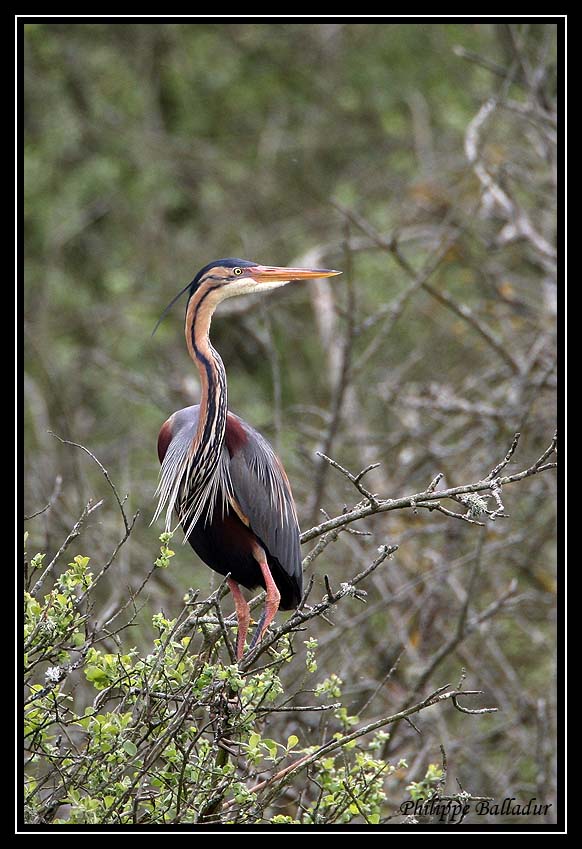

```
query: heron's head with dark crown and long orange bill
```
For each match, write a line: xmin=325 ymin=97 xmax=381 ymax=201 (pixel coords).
xmin=189 ymin=258 xmax=341 ymax=302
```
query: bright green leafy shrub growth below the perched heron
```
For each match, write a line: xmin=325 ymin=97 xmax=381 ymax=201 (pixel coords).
xmin=24 ymin=535 xmax=404 ymax=824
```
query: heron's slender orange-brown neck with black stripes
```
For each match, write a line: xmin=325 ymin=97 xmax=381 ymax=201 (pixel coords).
xmin=186 ymin=289 xmax=227 ymax=471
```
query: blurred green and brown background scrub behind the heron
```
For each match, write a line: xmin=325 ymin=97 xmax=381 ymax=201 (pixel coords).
xmin=24 ymin=21 xmax=557 ymax=820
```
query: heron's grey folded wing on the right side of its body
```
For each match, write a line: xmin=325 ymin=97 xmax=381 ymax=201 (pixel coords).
xmin=226 ymin=413 xmax=302 ymax=600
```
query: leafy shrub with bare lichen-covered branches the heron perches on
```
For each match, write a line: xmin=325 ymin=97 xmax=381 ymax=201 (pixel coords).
xmin=24 ymin=428 xmax=556 ymax=823
